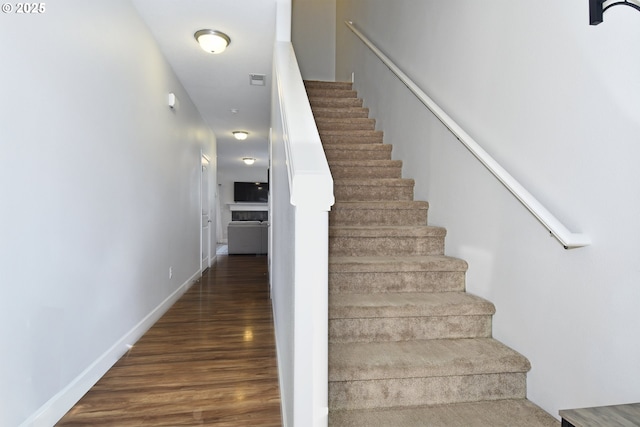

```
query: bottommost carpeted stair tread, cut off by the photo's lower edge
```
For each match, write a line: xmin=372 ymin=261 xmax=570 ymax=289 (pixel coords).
xmin=329 ymin=399 xmax=560 ymax=427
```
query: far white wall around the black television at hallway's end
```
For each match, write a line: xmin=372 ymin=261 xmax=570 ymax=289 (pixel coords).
xmin=218 ymin=165 xmax=267 ymax=243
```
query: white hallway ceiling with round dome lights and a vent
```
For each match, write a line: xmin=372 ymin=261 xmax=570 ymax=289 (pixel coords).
xmin=133 ymin=0 xmax=276 ymax=170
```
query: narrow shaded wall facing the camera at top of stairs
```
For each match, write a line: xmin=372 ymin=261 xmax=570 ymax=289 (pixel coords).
xmin=291 ymin=0 xmax=336 ymax=81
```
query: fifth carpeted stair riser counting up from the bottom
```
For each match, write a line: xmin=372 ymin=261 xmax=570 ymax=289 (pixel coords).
xmin=329 ymin=208 xmax=427 ymax=225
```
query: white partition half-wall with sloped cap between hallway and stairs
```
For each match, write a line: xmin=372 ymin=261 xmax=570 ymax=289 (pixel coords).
xmin=269 ymin=42 xmax=334 ymax=427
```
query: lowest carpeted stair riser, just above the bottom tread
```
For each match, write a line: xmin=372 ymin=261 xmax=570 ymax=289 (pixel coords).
xmin=329 ymin=374 xmax=526 ymax=410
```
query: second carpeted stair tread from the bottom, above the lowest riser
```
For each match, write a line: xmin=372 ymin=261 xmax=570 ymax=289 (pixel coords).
xmin=329 ymin=338 xmax=531 ymax=381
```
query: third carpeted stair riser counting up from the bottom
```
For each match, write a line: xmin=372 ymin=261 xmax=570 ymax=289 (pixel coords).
xmin=329 ymin=269 xmax=465 ymax=294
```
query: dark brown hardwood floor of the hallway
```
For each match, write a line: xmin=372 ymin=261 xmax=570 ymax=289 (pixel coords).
xmin=57 ymin=256 xmax=282 ymax=427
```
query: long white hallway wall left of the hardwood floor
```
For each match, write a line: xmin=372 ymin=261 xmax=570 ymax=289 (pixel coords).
xmin=0 ymin=0 xmax=215 ymax=426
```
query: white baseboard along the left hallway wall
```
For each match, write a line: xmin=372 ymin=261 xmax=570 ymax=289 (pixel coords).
xmin=20 ymin=271 xmax=202 ymax=427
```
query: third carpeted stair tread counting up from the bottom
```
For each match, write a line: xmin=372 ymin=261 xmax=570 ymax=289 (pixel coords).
xmin=329 ymin=292 xmax=495 ymax=319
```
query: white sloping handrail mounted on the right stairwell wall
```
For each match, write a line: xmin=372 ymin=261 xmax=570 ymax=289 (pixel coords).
xmin=345 ymin=21 xmax=591 ymax=249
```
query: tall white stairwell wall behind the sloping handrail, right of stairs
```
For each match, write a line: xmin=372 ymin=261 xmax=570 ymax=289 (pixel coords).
xmin=336 ymin=0 xmax=640 ymax=422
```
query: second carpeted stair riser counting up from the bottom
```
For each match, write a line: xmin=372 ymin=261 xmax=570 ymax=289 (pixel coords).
xmin=329 ymin=316 xmax=491 ymax=342
